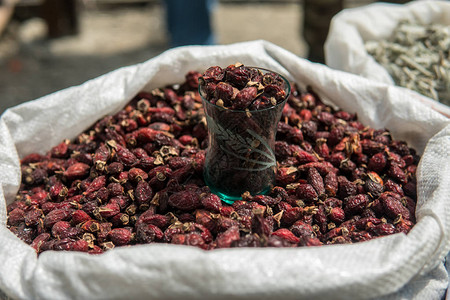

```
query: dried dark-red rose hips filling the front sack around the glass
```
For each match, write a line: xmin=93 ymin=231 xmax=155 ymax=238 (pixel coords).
xmin=7 ymin=68 xmax=419 ymax=253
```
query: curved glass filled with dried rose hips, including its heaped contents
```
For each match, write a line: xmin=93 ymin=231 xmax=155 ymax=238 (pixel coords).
xmin=199 ymin=63 xmax=291 ymax=203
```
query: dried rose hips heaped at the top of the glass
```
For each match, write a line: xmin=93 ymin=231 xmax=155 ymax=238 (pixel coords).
xmin=200 ymin=63 xmax=286 ymax=110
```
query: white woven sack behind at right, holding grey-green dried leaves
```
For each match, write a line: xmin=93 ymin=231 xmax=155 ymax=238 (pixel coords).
xmin=324 ymin=0 xmax=450 ymax=117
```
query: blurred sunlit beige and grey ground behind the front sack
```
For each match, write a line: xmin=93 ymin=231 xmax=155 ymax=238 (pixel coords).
xmin=0 ymin=2 xmax=306 ymax=114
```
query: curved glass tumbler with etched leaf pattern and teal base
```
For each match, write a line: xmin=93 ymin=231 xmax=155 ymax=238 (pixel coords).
xmin=199 ymin=68 xmax=290 ymax=204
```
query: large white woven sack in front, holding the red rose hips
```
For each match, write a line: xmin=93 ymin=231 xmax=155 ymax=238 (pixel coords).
xmin=0 ymin=41 xmax=450 ymax=299
